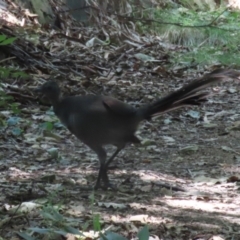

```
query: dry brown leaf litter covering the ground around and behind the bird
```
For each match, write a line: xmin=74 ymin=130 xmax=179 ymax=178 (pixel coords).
xmin=0 ymin=0 xmax=240 ymax=240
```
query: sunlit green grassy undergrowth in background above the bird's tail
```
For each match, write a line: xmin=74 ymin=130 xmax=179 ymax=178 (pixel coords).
xmin=135 ymin=5 xmax=240 ymax=66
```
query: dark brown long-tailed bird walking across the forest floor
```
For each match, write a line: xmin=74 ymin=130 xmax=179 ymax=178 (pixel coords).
xmin=36 ymin=70 xmax=239 ymax=189
